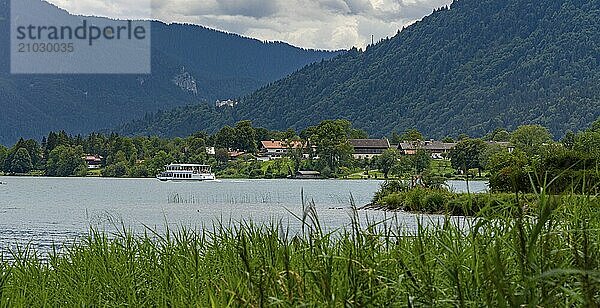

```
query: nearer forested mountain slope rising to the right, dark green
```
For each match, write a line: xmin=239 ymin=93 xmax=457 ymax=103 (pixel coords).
xmin=121 ymin=0 xmax=600 ymax=137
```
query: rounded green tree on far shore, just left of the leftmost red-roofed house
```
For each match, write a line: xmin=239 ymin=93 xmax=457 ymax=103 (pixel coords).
xmin=46 ymin=145 xmax=87 ymax=176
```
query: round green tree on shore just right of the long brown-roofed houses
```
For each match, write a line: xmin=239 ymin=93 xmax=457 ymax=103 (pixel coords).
xmin=450 ymin=139 xmax=487 ymax=176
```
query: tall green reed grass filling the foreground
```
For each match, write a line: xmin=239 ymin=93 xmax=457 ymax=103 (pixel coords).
xmin=0 ymin=194 xmax=600 ymax=307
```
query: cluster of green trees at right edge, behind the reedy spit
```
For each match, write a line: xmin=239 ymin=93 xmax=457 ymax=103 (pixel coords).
xmin=450 ymin=119 xmax=600 ymax=193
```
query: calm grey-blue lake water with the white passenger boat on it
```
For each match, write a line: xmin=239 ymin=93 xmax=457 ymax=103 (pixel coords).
xmin=0 ymin=177 xmax=487 ymax=252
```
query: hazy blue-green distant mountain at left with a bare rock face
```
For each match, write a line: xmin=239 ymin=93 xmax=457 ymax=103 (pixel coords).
xmin=0 ymin=0 xmax=339 ymax=144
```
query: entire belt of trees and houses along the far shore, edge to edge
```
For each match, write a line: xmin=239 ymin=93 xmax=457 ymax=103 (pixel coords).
xmin=0 ymin=120 xmax=600 ymax=184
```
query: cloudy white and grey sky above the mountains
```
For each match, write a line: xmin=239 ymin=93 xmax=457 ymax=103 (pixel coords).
xmin=47 ymin=0 xmax=451 ymax=49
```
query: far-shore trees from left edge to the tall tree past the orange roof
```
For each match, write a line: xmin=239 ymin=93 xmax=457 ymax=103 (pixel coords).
xmin=0 ymin=120 xmax=367 ymax=177
